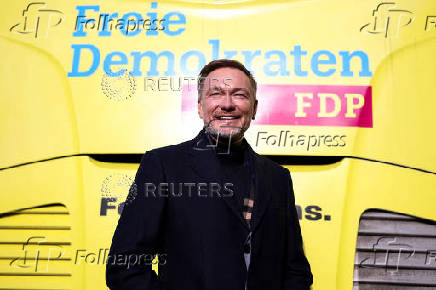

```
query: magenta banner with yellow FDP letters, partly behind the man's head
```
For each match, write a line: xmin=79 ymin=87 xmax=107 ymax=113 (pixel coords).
xmin=182 ymin=85 xmax=373 ymax=128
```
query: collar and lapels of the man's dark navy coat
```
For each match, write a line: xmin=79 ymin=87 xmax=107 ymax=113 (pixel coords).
xmin=186 ymin=129 xmax=272 ymax=232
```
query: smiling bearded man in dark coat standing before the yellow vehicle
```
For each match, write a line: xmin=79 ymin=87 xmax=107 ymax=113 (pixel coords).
xmin=106 ymin=59 xmax=312 ymax=290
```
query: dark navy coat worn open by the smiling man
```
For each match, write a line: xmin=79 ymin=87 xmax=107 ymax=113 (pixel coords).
xmin=106 ymin=131 xmax=312 ymax=290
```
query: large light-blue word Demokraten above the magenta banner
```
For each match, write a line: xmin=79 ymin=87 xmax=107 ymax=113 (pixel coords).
xmin=67 ymin=39 xmax=372 ymax=77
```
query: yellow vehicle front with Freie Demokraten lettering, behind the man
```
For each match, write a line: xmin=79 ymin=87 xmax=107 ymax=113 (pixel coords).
xmin=0 ymin=0 xmax=436 ymax=290
